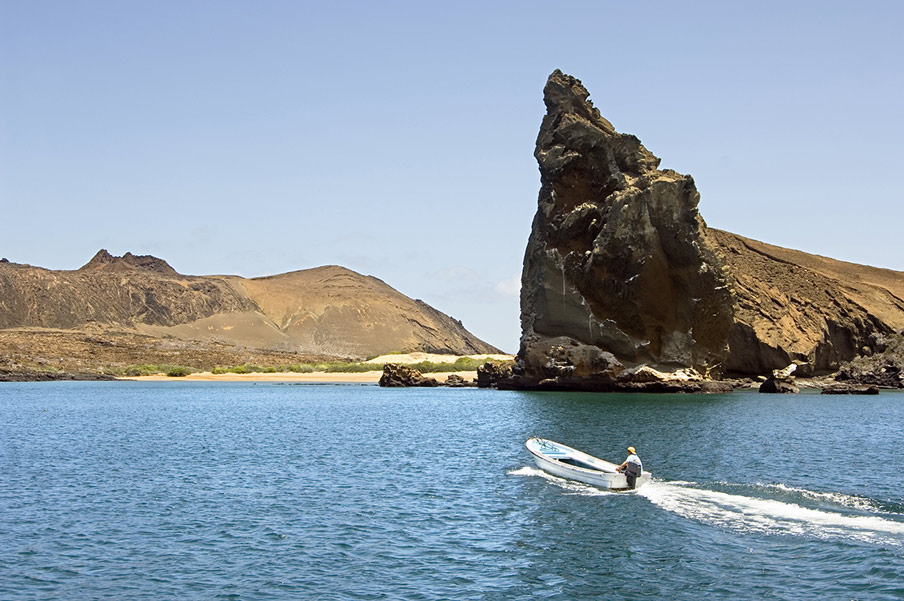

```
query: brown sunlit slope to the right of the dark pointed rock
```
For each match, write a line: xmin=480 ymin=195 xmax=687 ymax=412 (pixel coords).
xmin=708 ymin=229 xmax=904 ymax=374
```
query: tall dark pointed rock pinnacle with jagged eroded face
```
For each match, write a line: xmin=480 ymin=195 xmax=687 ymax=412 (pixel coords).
xmin=516 ymin=71 xmax=733 ymax=387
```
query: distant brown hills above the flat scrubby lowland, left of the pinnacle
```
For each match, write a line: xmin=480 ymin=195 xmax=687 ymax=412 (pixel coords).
xmin=0 ymin=250 xmax=498 ymax=376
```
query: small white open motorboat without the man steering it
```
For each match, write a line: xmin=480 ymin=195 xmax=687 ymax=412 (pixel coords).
xmin=525 ymin=437 xmax=650 ymax=490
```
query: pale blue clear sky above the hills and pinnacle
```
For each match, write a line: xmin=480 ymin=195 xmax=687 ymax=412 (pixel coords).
xmin=0 ymin=0 xmax=904 ymax=352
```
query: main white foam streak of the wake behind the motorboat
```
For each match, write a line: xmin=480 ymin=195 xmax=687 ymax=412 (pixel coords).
xmin=637 ymin=481 xmax=904 ymax=545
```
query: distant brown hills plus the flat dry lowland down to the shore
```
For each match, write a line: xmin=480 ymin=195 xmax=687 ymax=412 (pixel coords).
xmin=0 ymin=251 xmax=499 ymax=379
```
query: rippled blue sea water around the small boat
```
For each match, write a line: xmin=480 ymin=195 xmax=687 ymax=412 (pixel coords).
xmin=0 ymin=382 xmax=904 ymax=601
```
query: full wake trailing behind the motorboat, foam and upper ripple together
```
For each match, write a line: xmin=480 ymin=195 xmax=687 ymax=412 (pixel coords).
xmin=637 ymin=481 xmax=904 ymax=546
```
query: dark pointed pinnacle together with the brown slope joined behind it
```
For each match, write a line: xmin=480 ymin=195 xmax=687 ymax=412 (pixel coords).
xmin=507 ymin=71 xmax=904 ymax=390
